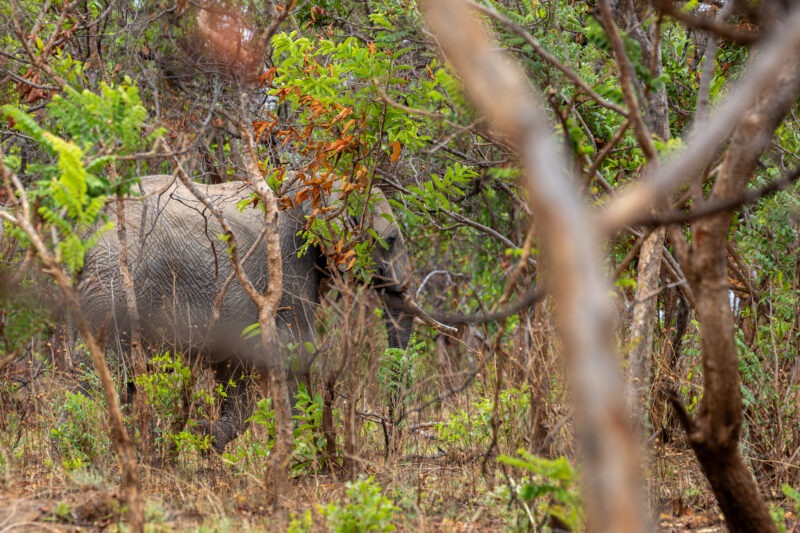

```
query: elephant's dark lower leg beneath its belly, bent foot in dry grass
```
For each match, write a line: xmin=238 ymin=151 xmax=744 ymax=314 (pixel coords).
xmin=200 ymin=364 xmax=253 ymax=453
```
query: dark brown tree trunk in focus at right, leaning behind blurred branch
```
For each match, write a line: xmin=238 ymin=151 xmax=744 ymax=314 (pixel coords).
xmin=677 ymin=50 xmax=800 ymax=532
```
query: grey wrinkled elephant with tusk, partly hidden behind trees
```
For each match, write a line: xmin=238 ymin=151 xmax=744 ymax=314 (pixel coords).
xmin=78 ymin=173 xmax=413 ymax=452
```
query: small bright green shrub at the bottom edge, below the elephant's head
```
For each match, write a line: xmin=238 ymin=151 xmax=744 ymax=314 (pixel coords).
xmin=319 ymin=476 xmax=399 ymax=533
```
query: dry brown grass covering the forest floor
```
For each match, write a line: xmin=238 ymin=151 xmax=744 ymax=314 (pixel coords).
xmin=0 ymin=310 xmax=795 ymax=533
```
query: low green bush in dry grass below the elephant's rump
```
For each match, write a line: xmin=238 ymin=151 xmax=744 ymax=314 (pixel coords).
xmin=50 ymin=386 xmax=111 ymax=470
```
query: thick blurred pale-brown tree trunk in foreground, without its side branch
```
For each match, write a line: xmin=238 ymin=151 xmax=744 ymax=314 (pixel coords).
xmin=421 ymin=0 xmax=647 ymax=532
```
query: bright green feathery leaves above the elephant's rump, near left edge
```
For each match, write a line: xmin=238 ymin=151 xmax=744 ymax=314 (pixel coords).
xmin=0 ymin=82 xmax=160 ymax=272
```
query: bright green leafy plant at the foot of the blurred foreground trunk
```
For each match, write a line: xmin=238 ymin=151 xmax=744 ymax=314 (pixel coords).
xmin=497 ymin=449 xmax=583 ymax=531
